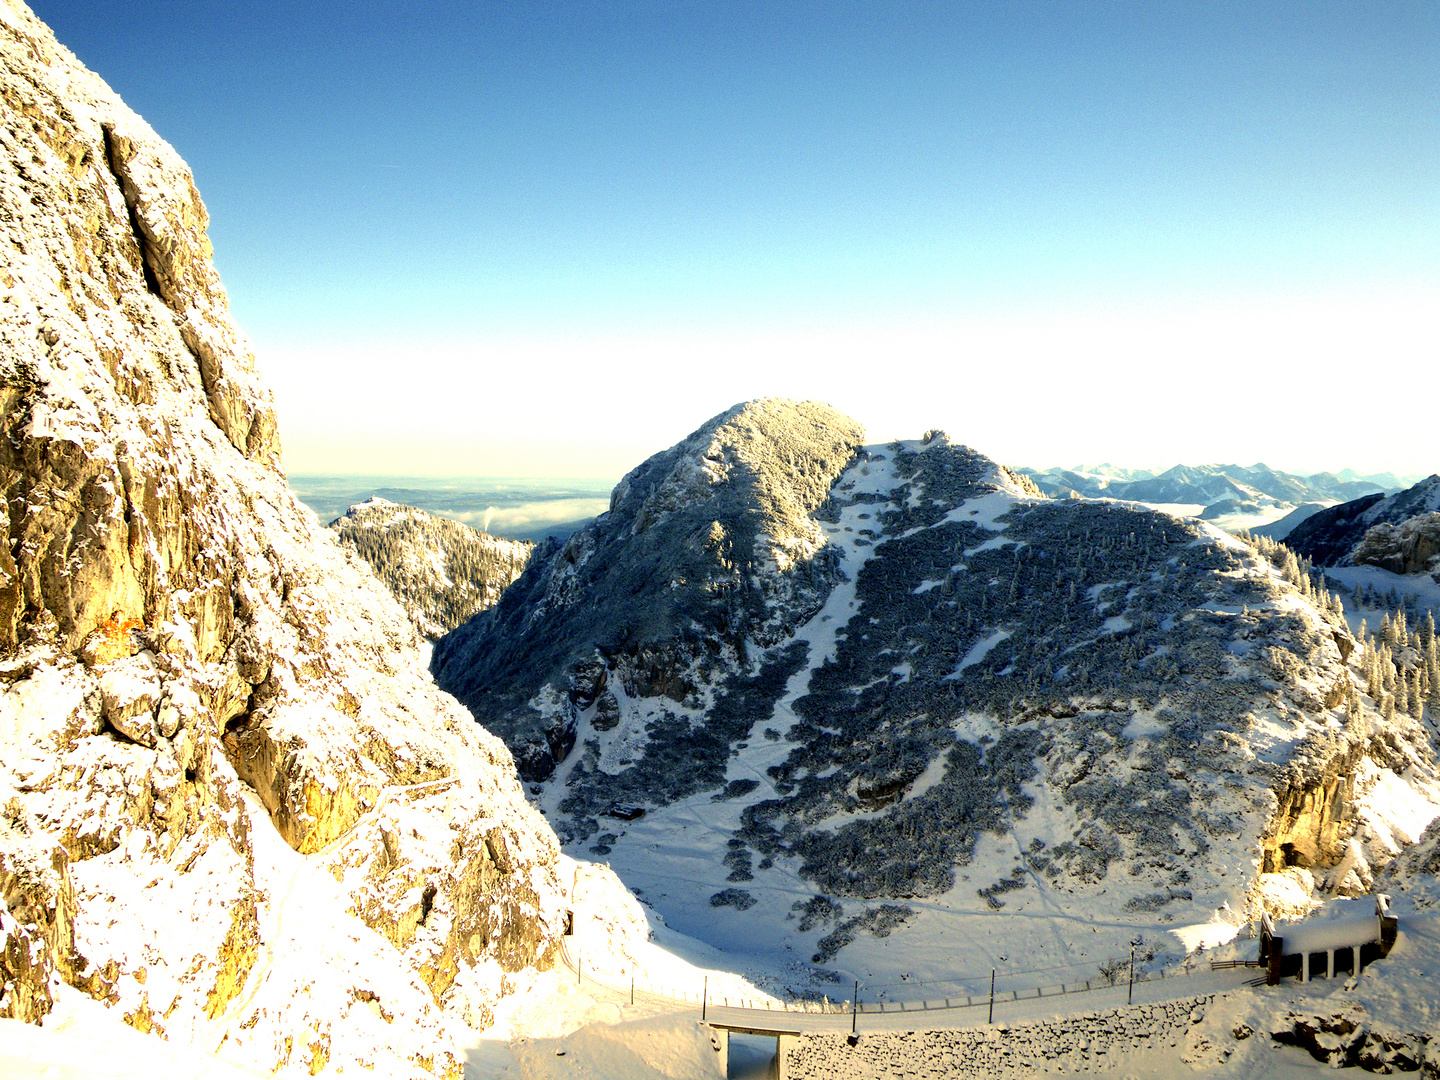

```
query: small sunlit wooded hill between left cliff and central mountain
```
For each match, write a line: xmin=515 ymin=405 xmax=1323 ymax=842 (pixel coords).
xmin=330 ymin=498 xmax=534 ymax=639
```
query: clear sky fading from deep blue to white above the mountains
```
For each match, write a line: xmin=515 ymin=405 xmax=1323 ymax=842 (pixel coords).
xmin=35 ymin=0 xmax=1440 ymax=477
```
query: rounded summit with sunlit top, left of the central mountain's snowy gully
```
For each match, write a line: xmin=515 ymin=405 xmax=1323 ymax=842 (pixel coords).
xmin=435 ymin=399 xmax=861 ymax=779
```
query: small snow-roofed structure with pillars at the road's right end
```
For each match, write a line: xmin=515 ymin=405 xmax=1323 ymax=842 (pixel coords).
xmin=1260 ymin=893 xmax=1400 ymax=986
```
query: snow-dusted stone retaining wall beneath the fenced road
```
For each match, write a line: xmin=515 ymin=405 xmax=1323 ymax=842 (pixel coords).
xmin=780 ymin=994 xmax=1214 ymax=1080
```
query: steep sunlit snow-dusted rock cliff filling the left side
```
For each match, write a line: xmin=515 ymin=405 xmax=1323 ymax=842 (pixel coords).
xmin=0 ymin=0 xmax=573 ymax=1077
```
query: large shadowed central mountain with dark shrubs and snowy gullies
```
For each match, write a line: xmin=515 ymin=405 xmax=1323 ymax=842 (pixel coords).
xmin=439 ymin=402 xmax=1440 ymax=996
